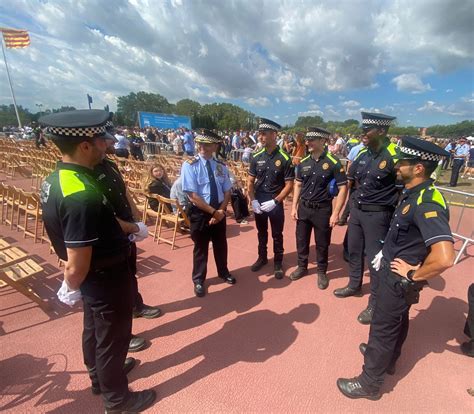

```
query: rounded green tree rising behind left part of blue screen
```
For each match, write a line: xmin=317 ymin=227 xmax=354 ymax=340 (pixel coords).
xmin=116 ymin=91 xmax=174 ymax=126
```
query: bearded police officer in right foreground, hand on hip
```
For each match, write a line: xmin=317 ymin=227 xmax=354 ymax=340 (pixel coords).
xmin=337 ymin=137 xmax=454 ymax=400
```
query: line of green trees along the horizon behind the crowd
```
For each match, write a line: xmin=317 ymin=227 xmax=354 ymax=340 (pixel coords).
xmin=0 ymin=95 xmax=474 ymax=138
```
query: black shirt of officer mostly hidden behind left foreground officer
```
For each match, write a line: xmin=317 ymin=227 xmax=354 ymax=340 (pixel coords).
xmin=94 ymin=158 xmax=134 ymax=222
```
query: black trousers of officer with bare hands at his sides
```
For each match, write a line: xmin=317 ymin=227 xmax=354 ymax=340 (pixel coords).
xmin=296 ymin=202 xmax=332 ymax=273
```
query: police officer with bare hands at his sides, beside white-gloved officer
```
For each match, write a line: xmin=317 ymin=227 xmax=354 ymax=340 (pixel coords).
xmin=290 ymin=127 xmax=347 ymax=289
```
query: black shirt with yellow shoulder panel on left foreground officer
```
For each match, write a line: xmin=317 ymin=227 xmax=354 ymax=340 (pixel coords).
xmin=41 ymin=162 xmax=130 ymax=262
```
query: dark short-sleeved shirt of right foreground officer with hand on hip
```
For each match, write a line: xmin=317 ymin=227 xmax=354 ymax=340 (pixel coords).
xmin=383 ymin=180 xmax=454 ymax=265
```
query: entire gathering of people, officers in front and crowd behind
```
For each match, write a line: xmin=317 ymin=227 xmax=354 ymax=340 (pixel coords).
xmin=4 ymin=110 xmax=474 ymax=413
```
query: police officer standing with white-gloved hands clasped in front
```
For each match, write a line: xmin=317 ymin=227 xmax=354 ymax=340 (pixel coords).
xmin=248 ymin=118 xmax=295 ymax=279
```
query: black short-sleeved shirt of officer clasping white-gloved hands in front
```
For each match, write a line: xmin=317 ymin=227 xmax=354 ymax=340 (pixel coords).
xmin=249 ymin=146 xmax=295 ymax=201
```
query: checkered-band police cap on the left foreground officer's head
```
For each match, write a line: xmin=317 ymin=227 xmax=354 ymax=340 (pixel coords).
xmin=39 ymin=109 xmax=110 ymax=139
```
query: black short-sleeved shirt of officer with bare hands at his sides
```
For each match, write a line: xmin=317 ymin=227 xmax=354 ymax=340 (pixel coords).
xmin=296 ymin=151 xmax=347 ymax=203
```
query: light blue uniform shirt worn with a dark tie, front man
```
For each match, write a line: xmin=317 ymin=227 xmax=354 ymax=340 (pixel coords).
xmin=181 ymin=155 xmax=232 ymax=204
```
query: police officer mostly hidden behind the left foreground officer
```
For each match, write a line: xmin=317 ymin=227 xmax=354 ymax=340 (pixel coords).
xmin=94 ymin=121 xmax=161 ymax=352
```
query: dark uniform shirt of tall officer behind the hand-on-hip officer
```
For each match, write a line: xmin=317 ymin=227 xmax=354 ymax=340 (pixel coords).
xmin=347 ymin=143 xmax=403 ymax=207
